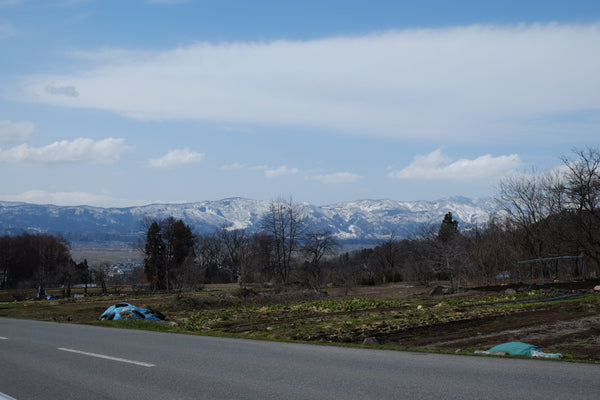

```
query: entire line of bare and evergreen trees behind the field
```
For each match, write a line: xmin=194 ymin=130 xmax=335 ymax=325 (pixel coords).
xmin=0 ymin=148 xmax=600 ymax=294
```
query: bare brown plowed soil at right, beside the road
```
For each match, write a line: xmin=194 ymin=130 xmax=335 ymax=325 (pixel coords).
xmin=342 ymin=281 xmax=600 ymax=362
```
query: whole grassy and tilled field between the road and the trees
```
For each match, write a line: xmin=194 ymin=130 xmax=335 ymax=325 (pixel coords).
xmin=0 ymin=283 xmax=600 ymax=362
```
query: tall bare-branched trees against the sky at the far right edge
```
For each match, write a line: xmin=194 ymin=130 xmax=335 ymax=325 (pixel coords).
xmin=500 ymin=148 xmax=600 ymax=267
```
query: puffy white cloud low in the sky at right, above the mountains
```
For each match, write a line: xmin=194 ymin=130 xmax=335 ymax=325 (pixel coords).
xmin=388 ymin=150 xmax=521 ymax=182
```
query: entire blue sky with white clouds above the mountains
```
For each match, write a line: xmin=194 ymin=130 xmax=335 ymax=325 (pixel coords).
xmin=0 ymin=0 xmax=600 ymax=206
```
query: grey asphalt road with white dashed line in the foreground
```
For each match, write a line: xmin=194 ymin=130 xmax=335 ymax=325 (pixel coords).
xmin=0 ymin=318 xmax=600 ymax=400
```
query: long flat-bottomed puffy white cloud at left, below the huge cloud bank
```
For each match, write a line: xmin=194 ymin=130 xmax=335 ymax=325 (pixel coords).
xmin=0 ymin=138 xmax=133 ymax=164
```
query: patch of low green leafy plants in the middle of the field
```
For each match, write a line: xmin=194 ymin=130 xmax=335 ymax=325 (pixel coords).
xmin=172 ymin=295 xmax=568 ymax=343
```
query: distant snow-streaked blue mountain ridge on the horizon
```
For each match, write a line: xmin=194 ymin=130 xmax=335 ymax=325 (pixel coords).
xmin=0 ymin=197 xmax=495 ymax=247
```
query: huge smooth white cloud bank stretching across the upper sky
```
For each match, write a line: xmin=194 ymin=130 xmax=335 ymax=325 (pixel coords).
xmin=17 ymin=24 xmax=600 ymax=140
